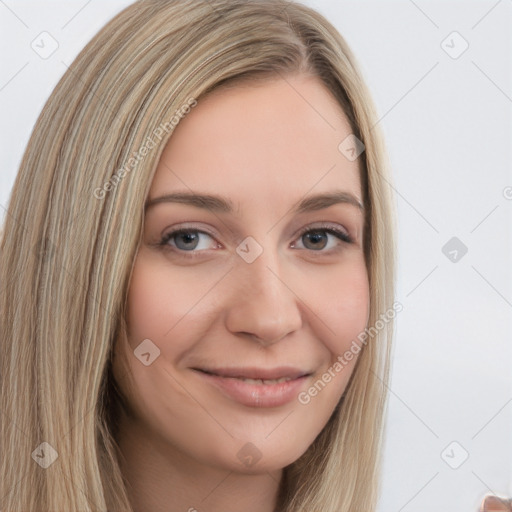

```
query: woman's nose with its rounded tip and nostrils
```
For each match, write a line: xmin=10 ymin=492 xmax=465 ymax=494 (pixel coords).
xmin=226 ymin=245 xmax=302 ymax=346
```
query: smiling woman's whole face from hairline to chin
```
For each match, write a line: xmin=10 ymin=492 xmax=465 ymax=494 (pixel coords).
xmin=114 ymin=75 xmax=369 ymax=473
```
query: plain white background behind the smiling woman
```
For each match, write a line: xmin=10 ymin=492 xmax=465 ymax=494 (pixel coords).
xmin=0 ymin=0 xmax=512 ymax=512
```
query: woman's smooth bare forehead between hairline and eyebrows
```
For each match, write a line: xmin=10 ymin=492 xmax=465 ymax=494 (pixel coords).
xmin=150 ymin=75 xmax=362 ymax=206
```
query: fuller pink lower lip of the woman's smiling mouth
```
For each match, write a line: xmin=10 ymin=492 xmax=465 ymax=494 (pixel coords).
xmin=196 ymin=370 xmax=309 ymax=407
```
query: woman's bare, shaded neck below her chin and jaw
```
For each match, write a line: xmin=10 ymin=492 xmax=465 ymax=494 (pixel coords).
xmin=118 ymin=414 xmax=282 ymax=512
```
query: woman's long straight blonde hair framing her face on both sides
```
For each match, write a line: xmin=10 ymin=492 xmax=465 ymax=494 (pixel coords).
xmin=0 ymin=0 xmax=395 ymax=512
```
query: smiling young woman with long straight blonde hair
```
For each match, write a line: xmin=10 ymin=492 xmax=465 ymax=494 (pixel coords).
xmin=0 ymin=0 xmax=400 ymax=512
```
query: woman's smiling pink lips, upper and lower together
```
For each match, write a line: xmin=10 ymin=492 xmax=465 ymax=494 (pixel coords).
xmin=193 ymin=367 xmax=311 ymax=408
